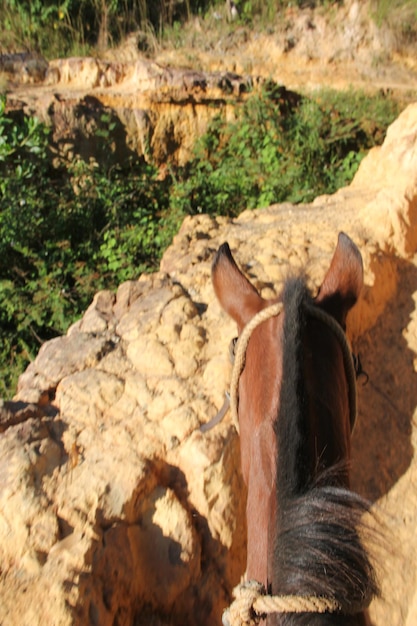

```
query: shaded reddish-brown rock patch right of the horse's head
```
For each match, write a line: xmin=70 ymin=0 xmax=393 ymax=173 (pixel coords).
xmin=352 ymin=261 xmax=417 ymax=501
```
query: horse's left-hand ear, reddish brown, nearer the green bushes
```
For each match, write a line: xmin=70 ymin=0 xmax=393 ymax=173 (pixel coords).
xmin=211 ymin=243 xmax=264 ymax=331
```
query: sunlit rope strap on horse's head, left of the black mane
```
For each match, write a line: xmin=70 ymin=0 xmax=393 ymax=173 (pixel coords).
xmin=230 ymin=302 xmax=283 ymax=432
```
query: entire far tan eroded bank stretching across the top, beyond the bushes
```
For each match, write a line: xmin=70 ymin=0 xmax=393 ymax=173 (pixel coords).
xmin=5 ymin=0 xmax=417 ymax=168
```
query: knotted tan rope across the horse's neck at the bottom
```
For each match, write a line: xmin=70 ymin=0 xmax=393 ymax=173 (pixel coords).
xmin=222 ymin=580 xmax=340 ymax=626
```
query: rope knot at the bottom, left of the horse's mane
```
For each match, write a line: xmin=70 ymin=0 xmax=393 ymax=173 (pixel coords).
xmin=222 ymin=580 xmax=266 ymax=626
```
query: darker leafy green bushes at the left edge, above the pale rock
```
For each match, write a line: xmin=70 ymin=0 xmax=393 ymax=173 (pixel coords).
xmin=0 ymin=99 xmax=169 ymax=396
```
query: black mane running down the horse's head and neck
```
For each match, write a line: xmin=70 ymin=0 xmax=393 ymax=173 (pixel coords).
xmin=268 ymin=279 xmax=378 ymax=626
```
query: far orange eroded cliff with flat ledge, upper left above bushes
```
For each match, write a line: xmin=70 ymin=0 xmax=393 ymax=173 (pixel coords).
xmin=0 ymin=55 xmax=266 ymax=165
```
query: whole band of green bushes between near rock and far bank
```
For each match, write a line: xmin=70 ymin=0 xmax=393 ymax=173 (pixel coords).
xmin=0 ymin=88 xmax=398 ymax=396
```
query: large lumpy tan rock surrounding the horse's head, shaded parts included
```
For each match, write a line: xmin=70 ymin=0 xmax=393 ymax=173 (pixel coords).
xmin=0 ymin=105 xmax=417 ymax=626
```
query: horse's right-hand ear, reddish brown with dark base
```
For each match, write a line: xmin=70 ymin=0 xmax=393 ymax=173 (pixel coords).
xmin=316 ymin=233 xmax=363 ymax=326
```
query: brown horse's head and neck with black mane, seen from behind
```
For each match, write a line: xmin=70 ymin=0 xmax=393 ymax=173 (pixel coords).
xmin=212 ymin=233 xmax=378 ymax=626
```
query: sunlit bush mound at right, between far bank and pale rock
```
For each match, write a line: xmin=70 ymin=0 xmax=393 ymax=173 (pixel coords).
xmin=173 ymin=84 xmax=398 ymax=215
